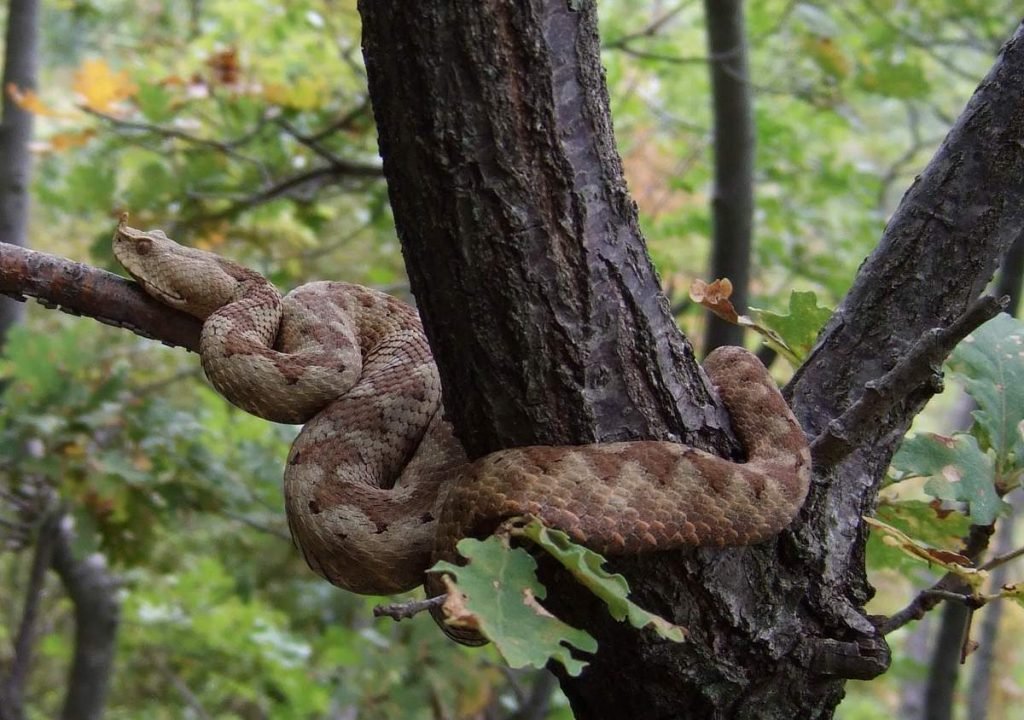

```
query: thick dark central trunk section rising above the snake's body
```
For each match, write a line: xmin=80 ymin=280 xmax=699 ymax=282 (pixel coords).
xmin=360 ymin=2 xmax=741 ymax=456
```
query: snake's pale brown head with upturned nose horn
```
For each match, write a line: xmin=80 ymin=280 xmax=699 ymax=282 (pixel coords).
xmin=114 ymin=219 xmax=252 ymax=320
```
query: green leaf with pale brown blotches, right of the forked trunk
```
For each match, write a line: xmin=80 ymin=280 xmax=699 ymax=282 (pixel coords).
xmin=893 ymin=432 xmax=1006 ymax=525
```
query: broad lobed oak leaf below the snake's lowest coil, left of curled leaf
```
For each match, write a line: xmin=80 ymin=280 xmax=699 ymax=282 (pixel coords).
xmin=430 ymin=537 xmax=597 ymax=676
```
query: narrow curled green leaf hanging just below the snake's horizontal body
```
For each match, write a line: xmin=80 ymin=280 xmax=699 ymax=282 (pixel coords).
xmin=517 ymin=519 xmax=686 ymax=642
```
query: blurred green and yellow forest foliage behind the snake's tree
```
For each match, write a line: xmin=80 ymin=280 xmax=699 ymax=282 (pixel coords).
xmin=0 ymin=0 xmax=1024 ymax=720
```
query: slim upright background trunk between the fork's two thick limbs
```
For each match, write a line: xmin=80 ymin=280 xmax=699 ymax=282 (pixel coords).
xmin=703 ymin=0 xmax=756 ymax=354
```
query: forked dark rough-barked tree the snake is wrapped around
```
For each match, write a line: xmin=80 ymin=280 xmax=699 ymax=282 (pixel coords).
xmin=0 ymin=5 xmax=1024 ymax=720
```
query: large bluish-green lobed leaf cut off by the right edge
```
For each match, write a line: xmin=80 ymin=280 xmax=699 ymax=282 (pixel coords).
xmin=949 ymin=313 xmax=1024 ymax=474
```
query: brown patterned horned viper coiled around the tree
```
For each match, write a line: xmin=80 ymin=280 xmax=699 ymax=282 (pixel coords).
xmin=114 ymin=225 xmax=811 ymax=642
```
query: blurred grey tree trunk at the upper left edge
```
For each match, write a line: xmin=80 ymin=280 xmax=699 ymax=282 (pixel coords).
xmin=0 ymin=0 xmax=39 ymax=347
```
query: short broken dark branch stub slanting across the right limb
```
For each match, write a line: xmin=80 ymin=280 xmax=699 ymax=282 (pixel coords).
xmin=811 ymin=295 xmax=1009 ymax=470
